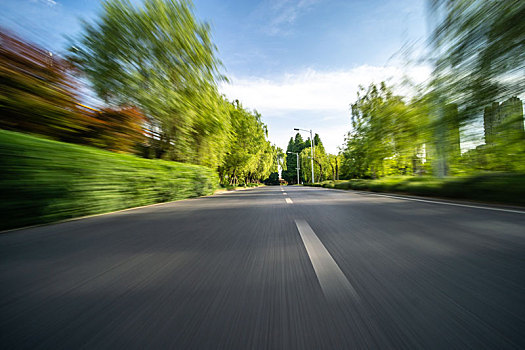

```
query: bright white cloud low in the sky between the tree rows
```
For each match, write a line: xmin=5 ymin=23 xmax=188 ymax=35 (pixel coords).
xmin=221 ymin=65 xmax=430 ymax=153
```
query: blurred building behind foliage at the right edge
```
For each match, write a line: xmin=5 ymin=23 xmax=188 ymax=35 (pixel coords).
xmin=483 ymin=97 xmax=525 ymax=145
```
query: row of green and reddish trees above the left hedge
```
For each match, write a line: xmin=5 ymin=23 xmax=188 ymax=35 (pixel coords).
xmin=0 ymin=0 xmax=283 ymax=186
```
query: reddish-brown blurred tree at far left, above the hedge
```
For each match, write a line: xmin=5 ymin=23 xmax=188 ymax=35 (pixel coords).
xmin=0 ymin=32 xmax=87 ymax=141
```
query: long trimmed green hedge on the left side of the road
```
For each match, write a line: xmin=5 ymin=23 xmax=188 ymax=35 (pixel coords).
xmin=0 ymin=130 xmax=218 ymax=229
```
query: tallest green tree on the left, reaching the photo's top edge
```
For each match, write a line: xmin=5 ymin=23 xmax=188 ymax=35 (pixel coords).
xmin=70 ymin=0 xmax=229 ymax=166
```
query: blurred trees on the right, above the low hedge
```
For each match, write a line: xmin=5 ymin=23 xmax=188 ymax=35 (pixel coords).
xmin=343 ymin=0 xmax=525 ymax=178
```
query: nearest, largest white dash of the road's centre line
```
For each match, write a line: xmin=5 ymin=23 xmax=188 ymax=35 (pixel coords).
xmin=295 ymin=220 xmax=359 ymax=301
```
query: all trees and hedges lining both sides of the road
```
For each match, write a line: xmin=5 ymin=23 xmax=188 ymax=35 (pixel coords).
xmin=0 ymin=0 xmax=525 ymax=231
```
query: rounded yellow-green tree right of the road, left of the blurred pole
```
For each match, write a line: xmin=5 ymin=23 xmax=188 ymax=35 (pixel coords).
xmin=342 ymin=83 xmax=430 ymax=178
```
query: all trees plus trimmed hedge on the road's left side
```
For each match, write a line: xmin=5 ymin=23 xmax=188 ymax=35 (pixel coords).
xmin=0 ymin=0 xmax=284 ymax=228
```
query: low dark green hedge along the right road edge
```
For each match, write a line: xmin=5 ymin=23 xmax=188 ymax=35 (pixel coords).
xmin=302 ymin=173 xmax=525 ymax=205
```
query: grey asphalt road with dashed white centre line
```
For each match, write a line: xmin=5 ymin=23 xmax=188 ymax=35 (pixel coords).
xmin=0 ymin=187 xmax=525 ymax=349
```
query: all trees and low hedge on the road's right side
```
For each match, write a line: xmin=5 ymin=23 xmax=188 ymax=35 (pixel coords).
xmin=298 ymin=0 xmax=525 ymax=204
